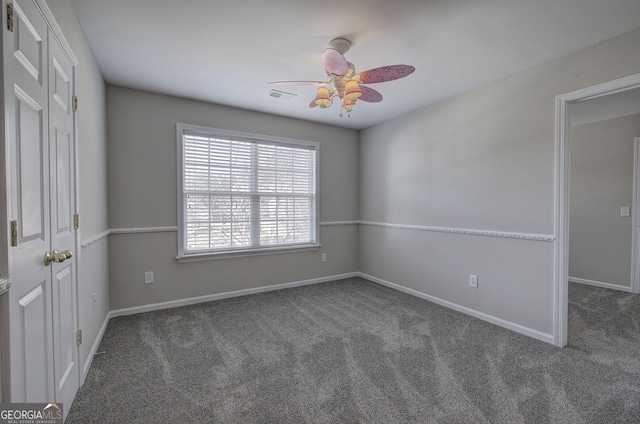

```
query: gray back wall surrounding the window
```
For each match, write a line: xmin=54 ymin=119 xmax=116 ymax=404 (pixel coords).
xmin=107 ymin=86 xmax=358 ymax=310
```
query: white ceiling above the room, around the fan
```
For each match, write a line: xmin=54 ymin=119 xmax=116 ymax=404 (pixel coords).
xmin=71 ymin=0 xmax=640 ymax=129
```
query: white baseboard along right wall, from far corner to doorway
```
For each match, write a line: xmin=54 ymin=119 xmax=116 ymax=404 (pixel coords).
xmin=358 ymin=272 xmax=553 ymax=344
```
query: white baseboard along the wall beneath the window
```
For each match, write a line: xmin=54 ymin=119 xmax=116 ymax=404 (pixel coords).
xmin=110 ymin=272 xmax=358 ymax=318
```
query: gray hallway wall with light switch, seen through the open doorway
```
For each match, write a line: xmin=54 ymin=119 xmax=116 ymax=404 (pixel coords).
xmin=569 ymin=115 xmax=640 ymax=287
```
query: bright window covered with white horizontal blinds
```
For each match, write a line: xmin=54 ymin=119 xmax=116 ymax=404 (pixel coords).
xmin=177 ymin=124 xmax=319 ymax=259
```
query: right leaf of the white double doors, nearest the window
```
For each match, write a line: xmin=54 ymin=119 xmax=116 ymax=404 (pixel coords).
xmin=49 ymin=24 xmax=80 ymax=413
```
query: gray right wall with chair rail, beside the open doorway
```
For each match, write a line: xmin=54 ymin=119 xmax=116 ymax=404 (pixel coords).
xmin=359 ymin=30 xmax=640 ymax=335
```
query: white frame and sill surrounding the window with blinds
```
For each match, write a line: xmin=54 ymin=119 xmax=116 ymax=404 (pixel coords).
xmin=176 ymin=123 xmax=322 ymax=262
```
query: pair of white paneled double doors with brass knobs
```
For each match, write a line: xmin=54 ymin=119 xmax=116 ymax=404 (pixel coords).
xmin=3 ymin=0 xmax=79 ymax=413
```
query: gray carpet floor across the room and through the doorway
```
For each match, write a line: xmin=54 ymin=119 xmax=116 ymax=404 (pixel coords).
xmin=66 ymin=278 xmax=640 ymax=424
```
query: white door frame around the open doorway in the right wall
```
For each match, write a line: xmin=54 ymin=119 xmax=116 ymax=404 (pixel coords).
xmin=553 ymin=73 xmax=640 ymax=347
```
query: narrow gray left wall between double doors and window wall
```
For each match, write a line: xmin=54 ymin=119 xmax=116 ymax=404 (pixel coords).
xmin=47 ymin=0 xmax=110 ymax=374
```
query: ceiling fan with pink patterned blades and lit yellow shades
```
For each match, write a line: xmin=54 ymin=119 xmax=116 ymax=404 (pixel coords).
xmin=269 ymin=38 xmax=416 ymax=117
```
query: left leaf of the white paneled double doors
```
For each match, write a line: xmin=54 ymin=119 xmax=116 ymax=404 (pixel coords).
xmin=4 ymin=1 xmax=54 ymax=402
